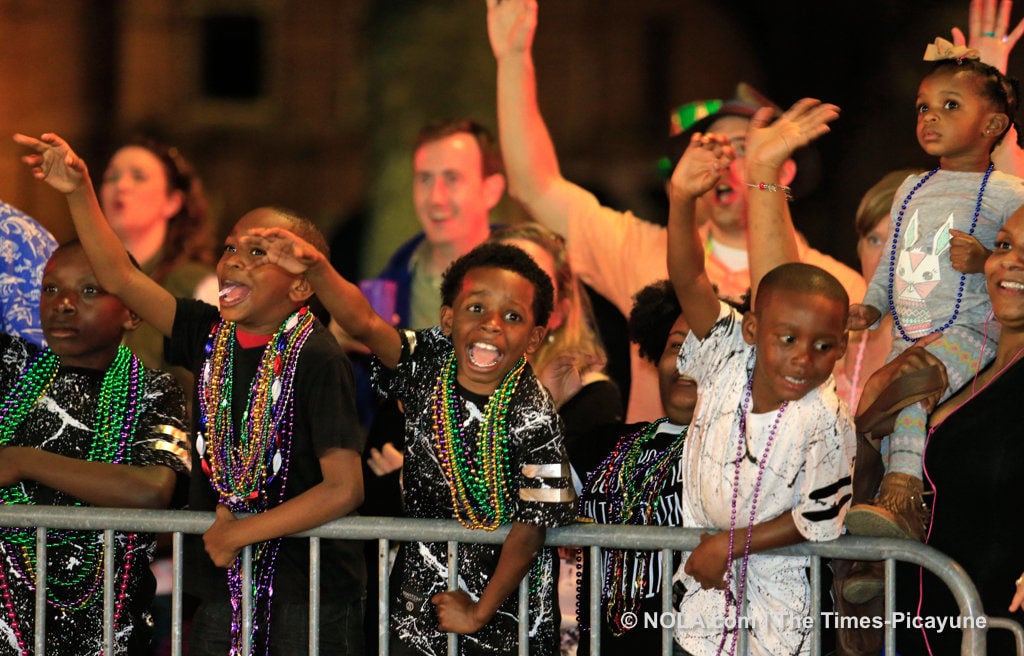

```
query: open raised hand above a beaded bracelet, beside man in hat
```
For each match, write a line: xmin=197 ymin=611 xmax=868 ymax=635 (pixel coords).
xmin=746 ymin=98 xmax=839 ymax=168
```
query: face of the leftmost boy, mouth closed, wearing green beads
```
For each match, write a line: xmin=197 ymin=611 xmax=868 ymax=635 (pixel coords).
xmin=39 ymin=247 xmax=138 ymax=369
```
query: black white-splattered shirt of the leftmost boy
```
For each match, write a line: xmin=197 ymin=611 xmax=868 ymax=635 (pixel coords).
xmin=0 ymin=335 xmax=188 ymax=656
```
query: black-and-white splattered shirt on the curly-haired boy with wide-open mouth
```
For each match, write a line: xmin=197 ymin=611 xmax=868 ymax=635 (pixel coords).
xmin=374 ymin=327 xmax=575 ymax=656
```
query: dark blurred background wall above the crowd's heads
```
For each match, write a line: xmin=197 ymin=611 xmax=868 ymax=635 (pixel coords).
xmin=0 ymin=0 xmax=1024 ymax=274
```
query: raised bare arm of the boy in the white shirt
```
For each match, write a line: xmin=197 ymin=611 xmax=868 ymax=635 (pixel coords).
xmin=669 ymin=132 xmax=735 ymax=339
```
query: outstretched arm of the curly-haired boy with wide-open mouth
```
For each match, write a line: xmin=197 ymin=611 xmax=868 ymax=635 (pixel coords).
xmin=241 ymin=228 xmax=401 ymax=368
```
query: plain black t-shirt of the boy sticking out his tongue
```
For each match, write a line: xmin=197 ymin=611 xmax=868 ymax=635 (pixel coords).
xmin=165 ymin=299 xmax=366 ymax=604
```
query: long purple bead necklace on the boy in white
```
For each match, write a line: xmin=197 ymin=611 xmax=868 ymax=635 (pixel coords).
xmin=718 ymin=374 xmax=790 ymax=655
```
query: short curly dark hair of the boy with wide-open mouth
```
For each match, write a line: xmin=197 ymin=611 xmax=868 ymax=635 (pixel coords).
xmin=441 ymin=242 xmax=555 ymax=325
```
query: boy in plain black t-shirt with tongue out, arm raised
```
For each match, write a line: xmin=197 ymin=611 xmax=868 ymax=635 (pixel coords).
xmin=15 ymin=134 xmax=366 ymax=656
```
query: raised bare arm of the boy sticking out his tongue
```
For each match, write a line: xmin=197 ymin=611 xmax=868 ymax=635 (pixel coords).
xmin=14 ymin=133 xmax=175 ymax=337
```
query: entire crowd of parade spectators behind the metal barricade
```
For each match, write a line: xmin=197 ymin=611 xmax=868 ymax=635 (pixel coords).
xmin=0 ymin=0 xmax=1024 ymax=656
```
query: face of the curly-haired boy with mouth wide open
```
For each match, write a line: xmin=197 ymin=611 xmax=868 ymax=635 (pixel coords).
xmin=440 ymin=266 xmax=546 ymax=395
